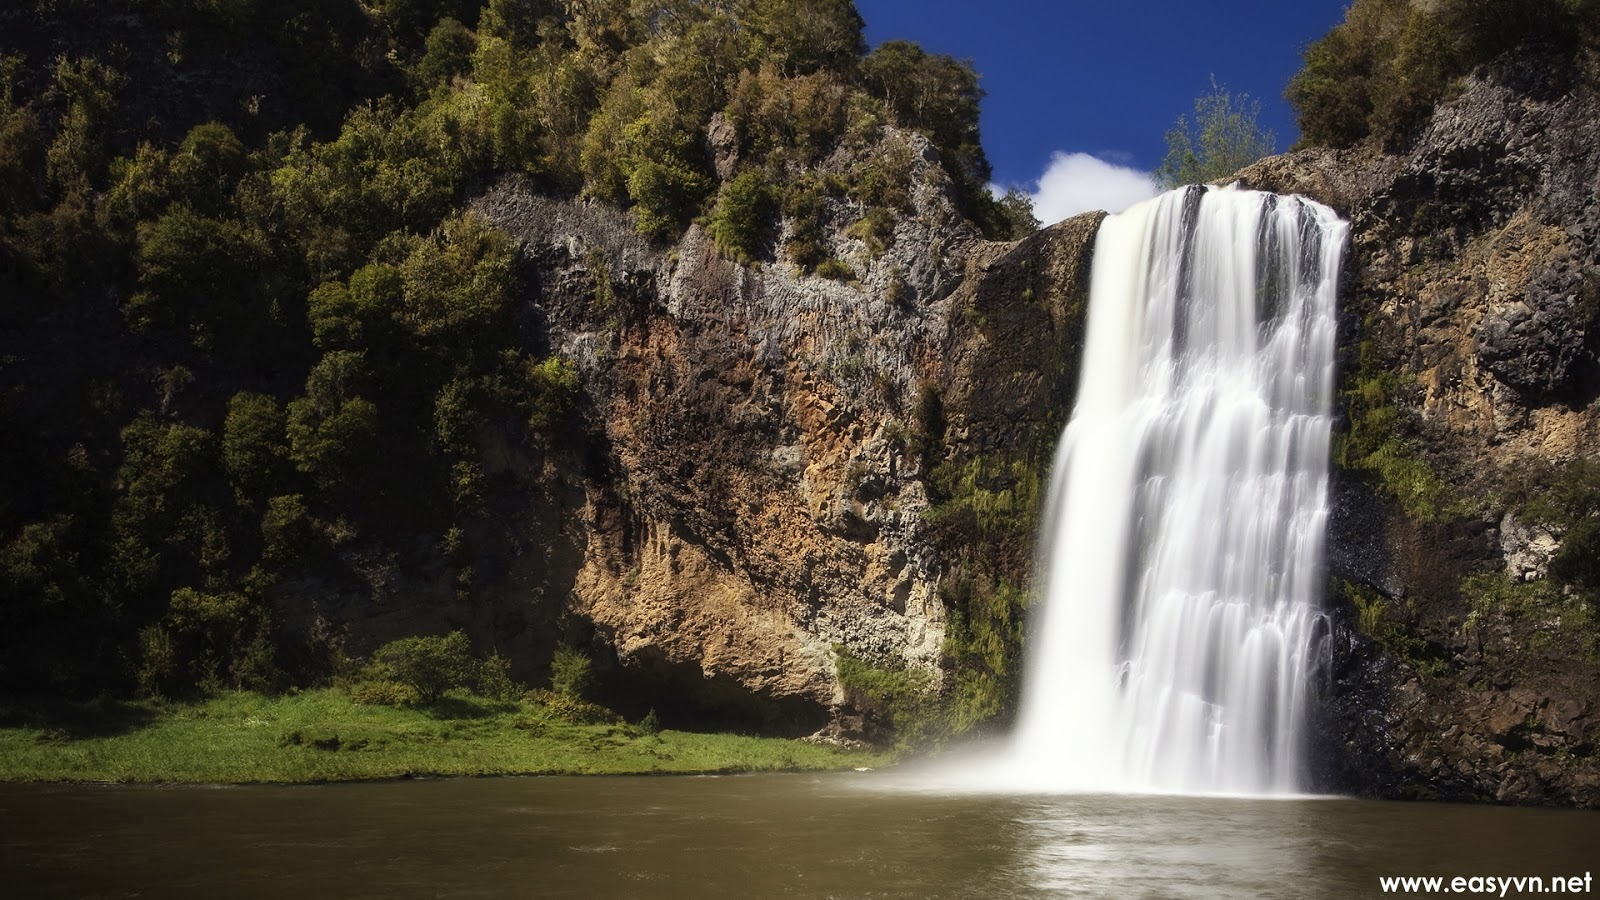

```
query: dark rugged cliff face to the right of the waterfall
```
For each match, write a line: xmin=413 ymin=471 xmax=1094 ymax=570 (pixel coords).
xmin=1240 ymin=54 xmax=1600 ymax=806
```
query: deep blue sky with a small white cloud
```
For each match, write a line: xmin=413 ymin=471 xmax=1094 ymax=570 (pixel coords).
xmin=856 ymin=0 xmax=1349 ymax=224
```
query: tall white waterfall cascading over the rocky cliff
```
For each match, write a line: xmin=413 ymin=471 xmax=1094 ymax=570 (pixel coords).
xmin=992 ymin=187 xmax=1347 ymax=794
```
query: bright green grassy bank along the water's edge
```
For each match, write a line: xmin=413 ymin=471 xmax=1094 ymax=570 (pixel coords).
xmin=0 ymin=690 xmax=886 ymax=783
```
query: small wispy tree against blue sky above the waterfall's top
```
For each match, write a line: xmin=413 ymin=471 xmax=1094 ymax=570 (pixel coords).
xmin=1155 ymin=75 xmax=1277 ymax=187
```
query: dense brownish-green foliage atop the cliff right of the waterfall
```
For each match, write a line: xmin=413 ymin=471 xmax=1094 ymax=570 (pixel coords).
xmin=1286 ymin=0 xmax=1600 ymax=147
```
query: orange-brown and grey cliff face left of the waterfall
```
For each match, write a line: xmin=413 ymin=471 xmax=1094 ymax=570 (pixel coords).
xmin=457 ymin=130 xmax=1094 ymax=733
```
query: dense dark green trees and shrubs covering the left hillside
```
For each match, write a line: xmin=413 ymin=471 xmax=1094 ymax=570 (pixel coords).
xmin=0 ymin=0 xmax=1027 ymax=697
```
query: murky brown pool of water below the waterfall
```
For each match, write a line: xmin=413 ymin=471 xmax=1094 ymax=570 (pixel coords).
xmin=0 ymin=773 xmax=1600 ymax=898
